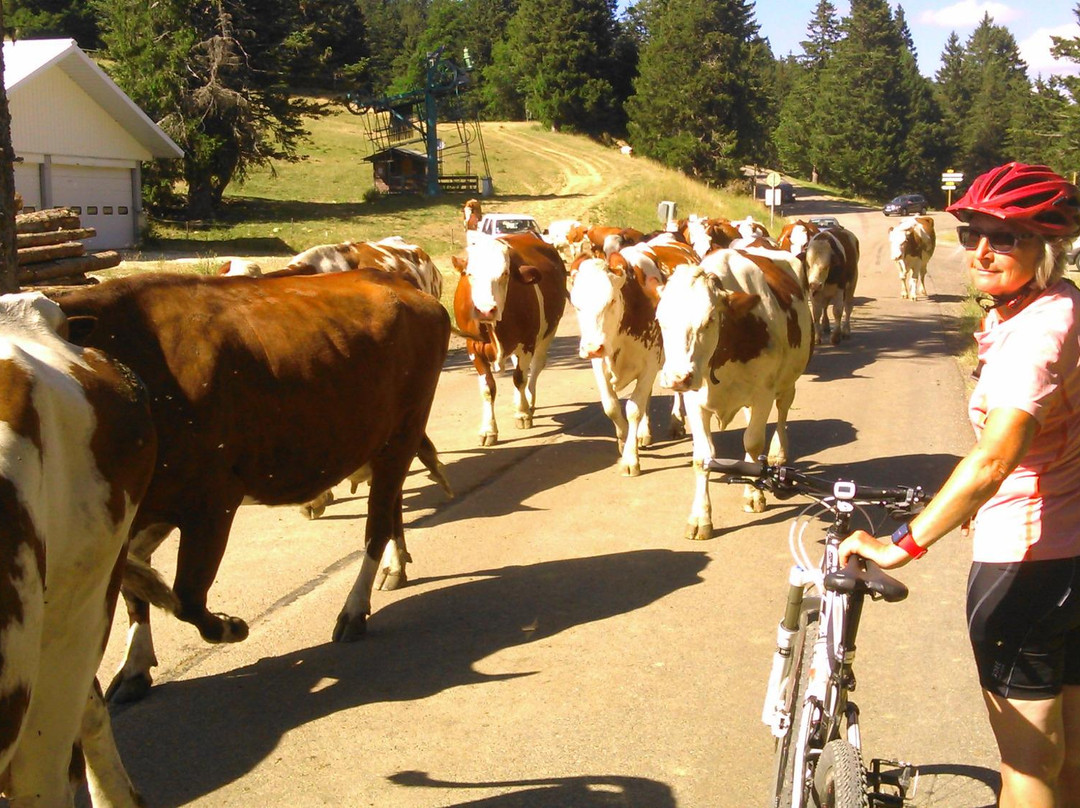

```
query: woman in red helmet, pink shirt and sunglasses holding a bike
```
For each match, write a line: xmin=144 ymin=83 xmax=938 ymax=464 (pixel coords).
xmin=840 ymin=163 xmax=1080 ymax=808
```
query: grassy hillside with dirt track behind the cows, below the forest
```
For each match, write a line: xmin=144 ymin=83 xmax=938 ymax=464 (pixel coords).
xmin=113 ymin=109 xmax=767 ymax=287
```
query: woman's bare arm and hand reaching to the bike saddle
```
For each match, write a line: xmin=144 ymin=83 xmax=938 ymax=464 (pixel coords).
xmin=840 ymin=407 xmax=1039 ymax=568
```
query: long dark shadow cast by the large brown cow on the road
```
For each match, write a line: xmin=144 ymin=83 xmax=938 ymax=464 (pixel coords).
xmin=113 ymin=550 xmax=708 ymax=808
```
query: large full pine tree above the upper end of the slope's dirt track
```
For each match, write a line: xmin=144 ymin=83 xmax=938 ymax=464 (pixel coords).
xmin=626 ymin=0 xmax=772 ymax=181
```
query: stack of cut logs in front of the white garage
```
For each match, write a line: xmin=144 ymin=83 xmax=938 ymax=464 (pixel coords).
xmin=15 ymin=207 xmax=120 ymax=285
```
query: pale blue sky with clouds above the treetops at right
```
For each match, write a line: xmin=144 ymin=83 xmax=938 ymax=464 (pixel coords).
xmin=755 ymin=0 xmax=1080 ymax=79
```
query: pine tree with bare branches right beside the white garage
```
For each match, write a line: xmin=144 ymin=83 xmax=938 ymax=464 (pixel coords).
xmin=95 ymin=0 xmax=321 ymax=218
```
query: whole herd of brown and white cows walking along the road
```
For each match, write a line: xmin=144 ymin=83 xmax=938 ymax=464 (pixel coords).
xmin=0 ymin=197 xmax=934 ymax=806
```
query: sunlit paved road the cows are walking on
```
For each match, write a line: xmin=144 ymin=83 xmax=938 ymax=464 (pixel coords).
xmin=103 ymin=198 xmax=996 ymax=808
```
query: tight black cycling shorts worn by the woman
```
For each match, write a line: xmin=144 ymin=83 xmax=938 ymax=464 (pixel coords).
xmin=968 ymin=557 xmax=1080 ymax=699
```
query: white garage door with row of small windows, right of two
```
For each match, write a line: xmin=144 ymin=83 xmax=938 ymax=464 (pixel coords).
xmin=53 ymin=164 xmax=135 ymax=250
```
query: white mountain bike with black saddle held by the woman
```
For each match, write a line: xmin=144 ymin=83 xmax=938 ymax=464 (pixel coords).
xmin=710 ymin=459 xmax=929 ymax=808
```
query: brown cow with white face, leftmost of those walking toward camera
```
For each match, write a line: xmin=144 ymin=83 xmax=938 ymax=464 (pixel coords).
xmin=453 ymin=233 xmax=566 ymax=446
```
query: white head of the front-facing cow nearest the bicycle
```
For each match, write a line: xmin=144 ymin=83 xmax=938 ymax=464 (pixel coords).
xmin=657 ymin=264 xmax=729 ymax=392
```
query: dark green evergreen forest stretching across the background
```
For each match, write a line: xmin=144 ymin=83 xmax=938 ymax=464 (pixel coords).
xmin=3 ymin=0 xmax=1080 ymax=217
